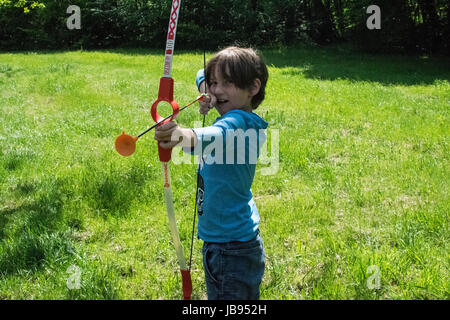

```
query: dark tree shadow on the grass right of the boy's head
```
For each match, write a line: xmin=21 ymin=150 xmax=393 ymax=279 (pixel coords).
xmin=263 ymin=47 xmax=450 ymax=86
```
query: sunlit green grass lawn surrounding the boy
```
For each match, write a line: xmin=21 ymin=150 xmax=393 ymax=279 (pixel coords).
xmin=0 ymin=48 xmax=450 ymax=299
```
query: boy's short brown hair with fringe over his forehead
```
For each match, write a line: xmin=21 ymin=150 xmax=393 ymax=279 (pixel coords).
xmin=205 ymin=47 xmax=269 ymax=109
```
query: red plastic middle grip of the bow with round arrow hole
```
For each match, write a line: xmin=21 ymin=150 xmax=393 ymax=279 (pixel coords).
xmin=150 ymin=77 xmax=180 ymax=162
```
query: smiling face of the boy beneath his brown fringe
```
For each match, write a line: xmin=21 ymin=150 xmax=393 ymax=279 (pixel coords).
xmin=208 ymin=66 xmax=259 ymax=115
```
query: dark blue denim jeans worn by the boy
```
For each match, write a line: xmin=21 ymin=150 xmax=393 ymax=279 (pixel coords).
xmin=202 ymin=231 xmax=265 ymax=300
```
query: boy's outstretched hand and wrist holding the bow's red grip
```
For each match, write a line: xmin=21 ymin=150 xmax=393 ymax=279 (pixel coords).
xmin=155 ymin=121 xmax=197 ymax=149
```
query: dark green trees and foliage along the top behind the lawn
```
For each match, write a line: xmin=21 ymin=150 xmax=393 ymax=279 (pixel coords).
xmin=0 ymin=0 xmax=450 ymax=53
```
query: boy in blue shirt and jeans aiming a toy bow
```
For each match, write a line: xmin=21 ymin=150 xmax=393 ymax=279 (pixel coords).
xmin=155 ymin=47 xmax=268 ymax=300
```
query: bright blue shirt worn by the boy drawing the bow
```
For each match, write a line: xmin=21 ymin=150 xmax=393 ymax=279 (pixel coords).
xmin=185 ymin=110 xmax=267 ymax=243
